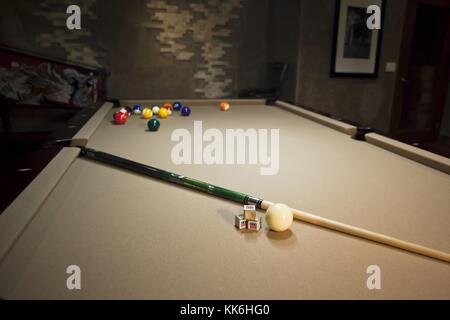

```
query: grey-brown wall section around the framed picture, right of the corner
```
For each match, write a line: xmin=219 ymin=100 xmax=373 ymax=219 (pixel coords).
xmin=296 ymin=0 xmax=406 ymax=132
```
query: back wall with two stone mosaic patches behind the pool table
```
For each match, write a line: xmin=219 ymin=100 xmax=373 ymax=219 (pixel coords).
xmin=0 ymin=0 xmax=268 ymax=98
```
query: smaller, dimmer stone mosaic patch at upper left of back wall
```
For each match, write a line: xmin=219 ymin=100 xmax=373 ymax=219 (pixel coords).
xmin=33 ymin=0 xmax=103 ymax=66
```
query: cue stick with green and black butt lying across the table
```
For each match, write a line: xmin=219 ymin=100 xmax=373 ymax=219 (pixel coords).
xmin=71 ymin=141 xmax=450 ymax=262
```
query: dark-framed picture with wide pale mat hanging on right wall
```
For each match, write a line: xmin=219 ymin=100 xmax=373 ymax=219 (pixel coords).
xmin=330 ymin=0 xmax=385 ymax=78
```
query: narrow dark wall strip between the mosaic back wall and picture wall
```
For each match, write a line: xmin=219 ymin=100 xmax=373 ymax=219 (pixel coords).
xmin=267 ymin=0 xmax=300 ymax=102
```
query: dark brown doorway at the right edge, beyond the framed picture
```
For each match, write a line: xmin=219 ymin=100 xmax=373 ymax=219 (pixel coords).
xmin=390 ymin=0 xmax=450 ymax=143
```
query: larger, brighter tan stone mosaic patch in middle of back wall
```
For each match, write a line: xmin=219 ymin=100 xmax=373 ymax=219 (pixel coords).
xmin=144 ymin=0 xmax=242 ymax=98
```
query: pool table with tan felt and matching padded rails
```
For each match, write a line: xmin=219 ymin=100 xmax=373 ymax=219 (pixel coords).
xmin=0 ymin=100 xmax=450 ymax=299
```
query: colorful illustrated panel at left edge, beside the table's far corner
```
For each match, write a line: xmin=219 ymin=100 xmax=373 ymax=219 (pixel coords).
xmin=0 ymin=50 xmax=101 ymax=107
